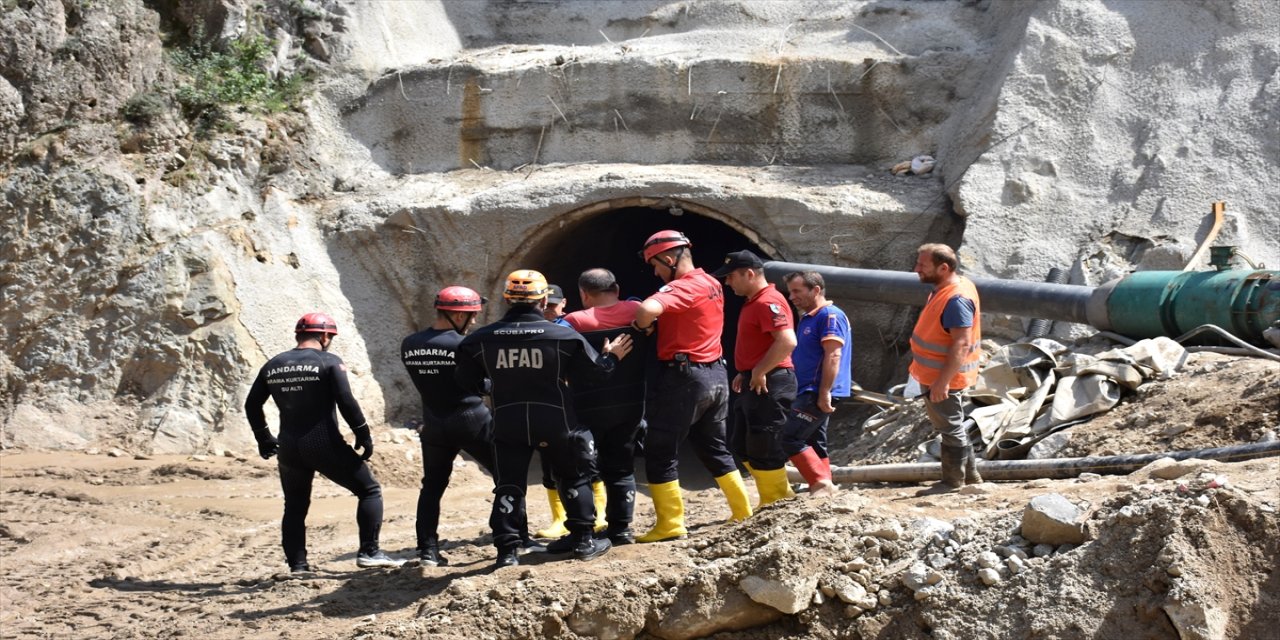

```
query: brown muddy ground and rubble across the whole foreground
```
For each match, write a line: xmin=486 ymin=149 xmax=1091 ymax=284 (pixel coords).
xmin=0 ymin=353 xmax=1280 ymax=639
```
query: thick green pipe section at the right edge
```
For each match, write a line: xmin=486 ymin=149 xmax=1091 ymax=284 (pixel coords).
xmin=1101 ymin=269 xmax=1280 ymax=344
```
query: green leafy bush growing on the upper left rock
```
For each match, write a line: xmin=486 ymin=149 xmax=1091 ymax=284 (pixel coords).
xmin=173 ymin=36 xmax=307 ymax=136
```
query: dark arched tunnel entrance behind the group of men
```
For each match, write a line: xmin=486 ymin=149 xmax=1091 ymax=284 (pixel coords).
xmin=518 ymin=200 xmax=783 ymax=371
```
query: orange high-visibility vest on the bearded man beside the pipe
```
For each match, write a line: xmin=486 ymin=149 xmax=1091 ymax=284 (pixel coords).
xmin=909 ymin=276 xmax=982 ymax=389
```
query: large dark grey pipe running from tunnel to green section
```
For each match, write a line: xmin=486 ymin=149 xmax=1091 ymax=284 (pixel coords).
xmin=764 ymin=261 xmax=1111 ymax=329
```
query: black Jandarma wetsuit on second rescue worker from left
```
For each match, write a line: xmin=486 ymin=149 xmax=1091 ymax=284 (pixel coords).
xmin=401 ymin=329 xmax=493 ymax=550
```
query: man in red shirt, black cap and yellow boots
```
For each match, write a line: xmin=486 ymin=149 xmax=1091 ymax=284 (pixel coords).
xmin=714 ymin=250 xmax=796 ymax=507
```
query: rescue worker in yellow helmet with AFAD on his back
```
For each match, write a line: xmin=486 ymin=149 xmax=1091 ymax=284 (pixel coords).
xmin=456 ymin=269 xmax=631 ymax=567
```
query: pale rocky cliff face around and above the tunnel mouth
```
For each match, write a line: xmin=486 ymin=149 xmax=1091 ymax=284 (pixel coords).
xmin=0 ymin=0 xmax=1280 ymax=452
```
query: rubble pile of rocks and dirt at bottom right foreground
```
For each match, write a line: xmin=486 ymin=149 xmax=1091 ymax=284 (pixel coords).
xmin=355 ymin=461 xmax=1280 ymax=640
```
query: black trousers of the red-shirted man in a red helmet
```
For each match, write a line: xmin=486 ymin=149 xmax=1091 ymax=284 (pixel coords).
xmin=644 ymin=362 xmax=737 ymax=484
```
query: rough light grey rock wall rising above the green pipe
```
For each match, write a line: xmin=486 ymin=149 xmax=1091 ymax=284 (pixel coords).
xmin=940 ymin=0 xmax=1280 ymax=284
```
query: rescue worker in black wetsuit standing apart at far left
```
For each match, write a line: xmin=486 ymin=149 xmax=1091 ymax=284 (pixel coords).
xmin=244 ymin=314 xmax=403 ymax=572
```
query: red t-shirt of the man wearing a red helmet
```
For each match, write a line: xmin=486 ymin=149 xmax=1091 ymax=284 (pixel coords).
xmin=649 ymin=269 xmax=724 ymax=362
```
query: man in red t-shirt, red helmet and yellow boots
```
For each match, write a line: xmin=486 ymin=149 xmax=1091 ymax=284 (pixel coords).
xmin=632 ymin=230 xmax=751 ymax=543
